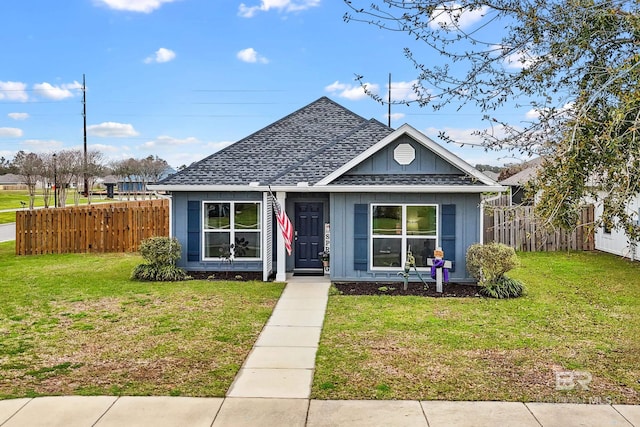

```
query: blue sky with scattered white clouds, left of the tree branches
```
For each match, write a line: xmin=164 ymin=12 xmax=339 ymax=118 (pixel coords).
xmin=0 ymin=0 xmax=527 ymax=168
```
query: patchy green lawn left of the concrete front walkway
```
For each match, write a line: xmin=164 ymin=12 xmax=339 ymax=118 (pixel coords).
xmin=0 ymin=242 xmax=282 ymax=398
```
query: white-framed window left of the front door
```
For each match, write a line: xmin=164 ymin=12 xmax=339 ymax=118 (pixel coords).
xmin=204 ymin=202 xmax=262 ymax=260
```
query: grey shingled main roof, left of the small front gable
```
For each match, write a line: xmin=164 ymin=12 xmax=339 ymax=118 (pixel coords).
xmin=158 ymin=97 xmax=393 ymax=186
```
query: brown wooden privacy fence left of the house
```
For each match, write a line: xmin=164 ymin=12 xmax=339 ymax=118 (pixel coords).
xmin=16 ymin=199 xmax=169 ymax=255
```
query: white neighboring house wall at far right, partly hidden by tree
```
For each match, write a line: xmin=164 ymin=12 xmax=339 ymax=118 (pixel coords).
xmin=594 ymin=196 xmax=640 ymax=260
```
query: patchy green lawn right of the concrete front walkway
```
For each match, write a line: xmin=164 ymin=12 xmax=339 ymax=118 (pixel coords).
xmin=312 ymin=253 xmax=640 ymax=404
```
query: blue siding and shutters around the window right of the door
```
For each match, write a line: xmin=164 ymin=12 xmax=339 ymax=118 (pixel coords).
xmin=331 ymin=193 xmax=480 ymax=282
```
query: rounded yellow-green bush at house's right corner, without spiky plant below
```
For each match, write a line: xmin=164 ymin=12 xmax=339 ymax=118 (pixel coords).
xmin=467 ymin=243 xmax=519 ymax=285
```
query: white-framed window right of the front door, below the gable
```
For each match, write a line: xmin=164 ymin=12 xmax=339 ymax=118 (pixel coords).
xmin=371 ymin=204 xmax=438 ymax=269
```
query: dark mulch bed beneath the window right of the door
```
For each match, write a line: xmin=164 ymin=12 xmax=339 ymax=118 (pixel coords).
xmin=333 ymin=282 xmax=480 ymax=298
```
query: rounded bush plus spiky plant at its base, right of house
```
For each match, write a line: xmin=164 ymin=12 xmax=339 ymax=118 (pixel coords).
xmin=467 ymin=243 xmax=524 ymax=298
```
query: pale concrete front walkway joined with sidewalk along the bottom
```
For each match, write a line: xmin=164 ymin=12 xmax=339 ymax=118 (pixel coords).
xmin=0 ymin=277 xmax=640 ymax=427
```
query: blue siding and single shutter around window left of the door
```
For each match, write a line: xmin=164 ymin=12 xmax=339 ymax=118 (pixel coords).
xmin=171 ymin=192 xmax=265 ymax=272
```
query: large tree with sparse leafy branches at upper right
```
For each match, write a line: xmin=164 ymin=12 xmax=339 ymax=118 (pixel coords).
xmin=344 ymin=0 xmax=640 ymax=239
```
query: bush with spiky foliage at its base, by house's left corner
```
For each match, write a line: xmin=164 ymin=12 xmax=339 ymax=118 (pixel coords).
xmin=131 ymin=237 xmax=191 ymax=282
